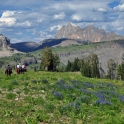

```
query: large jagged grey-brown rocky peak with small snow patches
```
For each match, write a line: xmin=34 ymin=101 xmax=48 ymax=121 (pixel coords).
xmin=55 ymin=22 xmax=124 ymax=42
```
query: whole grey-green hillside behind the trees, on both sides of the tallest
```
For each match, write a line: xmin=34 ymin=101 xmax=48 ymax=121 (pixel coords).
xmin=0 ymin=40 xmax=124 ymax=72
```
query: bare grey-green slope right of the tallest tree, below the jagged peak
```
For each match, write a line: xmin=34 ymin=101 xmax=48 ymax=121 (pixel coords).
xmin=35 ymin=40 xmax=124 ymax=72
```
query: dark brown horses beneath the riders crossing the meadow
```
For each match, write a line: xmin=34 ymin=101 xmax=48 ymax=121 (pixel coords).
xmin=5 ymin=68 xmax=26 ymax=76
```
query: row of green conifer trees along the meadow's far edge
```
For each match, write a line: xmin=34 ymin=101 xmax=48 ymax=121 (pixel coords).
xmin=40 ymin=47 xmax=124 ymax=80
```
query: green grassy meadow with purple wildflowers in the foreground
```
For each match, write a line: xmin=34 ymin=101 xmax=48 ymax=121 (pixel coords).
xmin=0 ymin=70 xmax=124 ymax=124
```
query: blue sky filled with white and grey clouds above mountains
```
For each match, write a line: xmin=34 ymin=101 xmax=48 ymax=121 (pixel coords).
xmin=0 ymin=0 xmax=124 ymax=43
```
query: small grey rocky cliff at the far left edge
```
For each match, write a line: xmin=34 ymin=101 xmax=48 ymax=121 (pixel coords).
xmin=0 ymin=34 xmax=10 ymax=49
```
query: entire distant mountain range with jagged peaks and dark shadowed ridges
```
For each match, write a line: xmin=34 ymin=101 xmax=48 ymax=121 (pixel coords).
xmin=0 ymin=22 xmax=124 ymax=52
